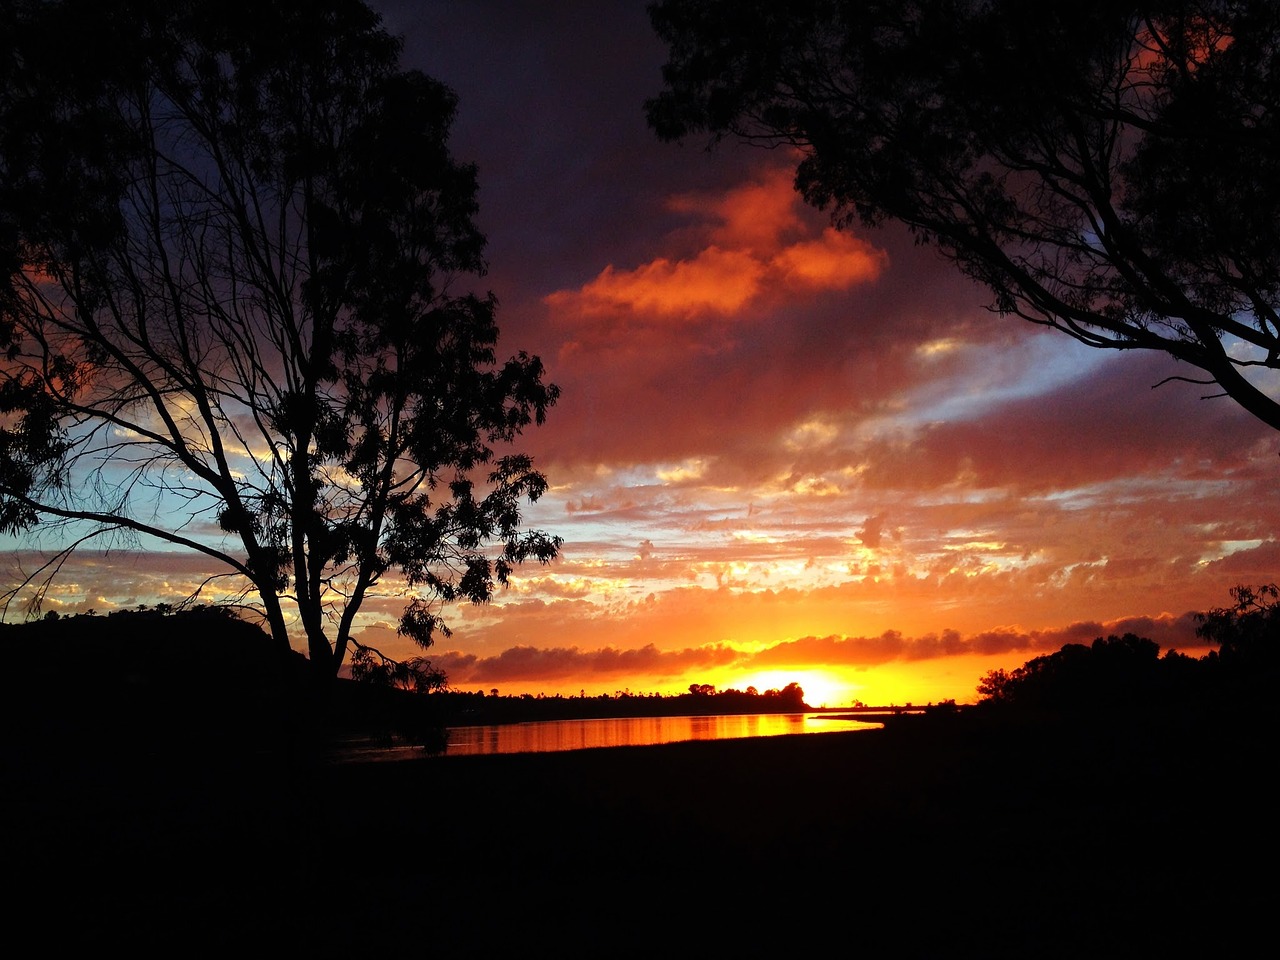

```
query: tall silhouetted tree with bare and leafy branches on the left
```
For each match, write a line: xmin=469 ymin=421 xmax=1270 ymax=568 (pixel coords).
xmin=0 ymin=0 xmax=559 ymax=676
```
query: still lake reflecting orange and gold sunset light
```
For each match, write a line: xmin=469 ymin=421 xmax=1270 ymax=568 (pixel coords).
xmin=344 ymin=713 xmax=881 ymax=760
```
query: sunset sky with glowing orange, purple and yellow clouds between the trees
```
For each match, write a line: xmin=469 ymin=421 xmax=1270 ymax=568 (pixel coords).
xmin=5 ymin=0 xmax=1280 ymax=705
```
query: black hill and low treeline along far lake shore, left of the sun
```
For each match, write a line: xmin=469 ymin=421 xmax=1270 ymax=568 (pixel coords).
xmin=0 ymin=605 xmax=810 ymax=754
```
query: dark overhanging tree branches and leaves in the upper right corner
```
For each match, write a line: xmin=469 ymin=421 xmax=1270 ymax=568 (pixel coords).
xmin=648 ymin=0 xmax=1280 ymax=428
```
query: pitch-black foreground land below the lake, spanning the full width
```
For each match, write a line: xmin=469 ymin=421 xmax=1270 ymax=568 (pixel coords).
xmin=0 ymin=714 xmax=1277 ymax=957
